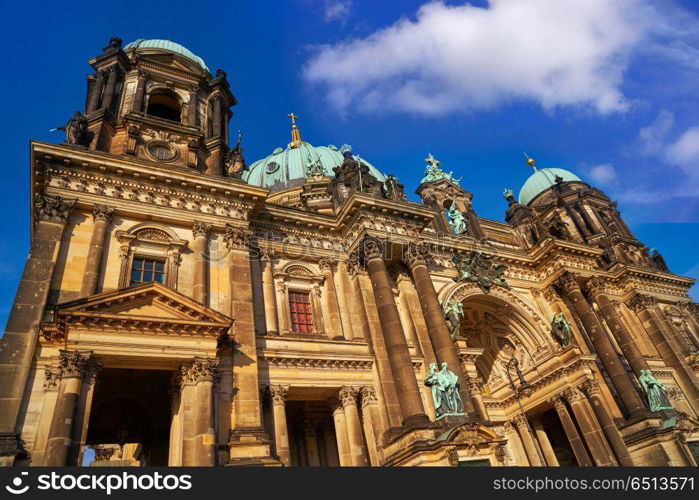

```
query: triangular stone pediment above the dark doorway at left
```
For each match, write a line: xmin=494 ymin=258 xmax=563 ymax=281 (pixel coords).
xmin=57 ymin=283 xmax=232 ymax=326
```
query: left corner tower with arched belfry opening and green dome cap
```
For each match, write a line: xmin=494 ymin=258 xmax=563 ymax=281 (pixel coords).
xmin=85 ymin=37 xmax=236 ymax=175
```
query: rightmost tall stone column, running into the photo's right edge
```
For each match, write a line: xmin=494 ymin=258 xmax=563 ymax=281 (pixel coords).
xmin=628 ymin=294 xmax=699 ymax=413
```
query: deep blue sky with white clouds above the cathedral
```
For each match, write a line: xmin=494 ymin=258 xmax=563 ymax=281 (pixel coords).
xmin=0 ymin=0 xmax=699 ymax=330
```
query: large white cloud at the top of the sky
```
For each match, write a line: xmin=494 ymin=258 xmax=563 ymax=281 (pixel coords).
xmin=304 ymin=0 xmax=649 ymax=114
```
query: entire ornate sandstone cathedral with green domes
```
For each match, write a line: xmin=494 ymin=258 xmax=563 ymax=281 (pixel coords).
xmin=0 ymin=37 xmax=699 ymax=467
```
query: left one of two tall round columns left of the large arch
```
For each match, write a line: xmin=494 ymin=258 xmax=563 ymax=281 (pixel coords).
xmin=362 ymin=237 xmax=429 ymax=425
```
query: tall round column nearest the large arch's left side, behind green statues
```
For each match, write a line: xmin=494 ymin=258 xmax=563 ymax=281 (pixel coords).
xmin=404 ymin=243 xmax=476 ymax=415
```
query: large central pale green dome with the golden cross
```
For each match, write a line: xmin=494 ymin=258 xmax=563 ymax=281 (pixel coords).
xmin=243 ymin=142 xmax=386 ymax=191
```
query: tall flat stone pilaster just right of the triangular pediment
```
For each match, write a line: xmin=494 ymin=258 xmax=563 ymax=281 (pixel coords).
xmin=224 ymin=224 xmax=272 ymax=465
